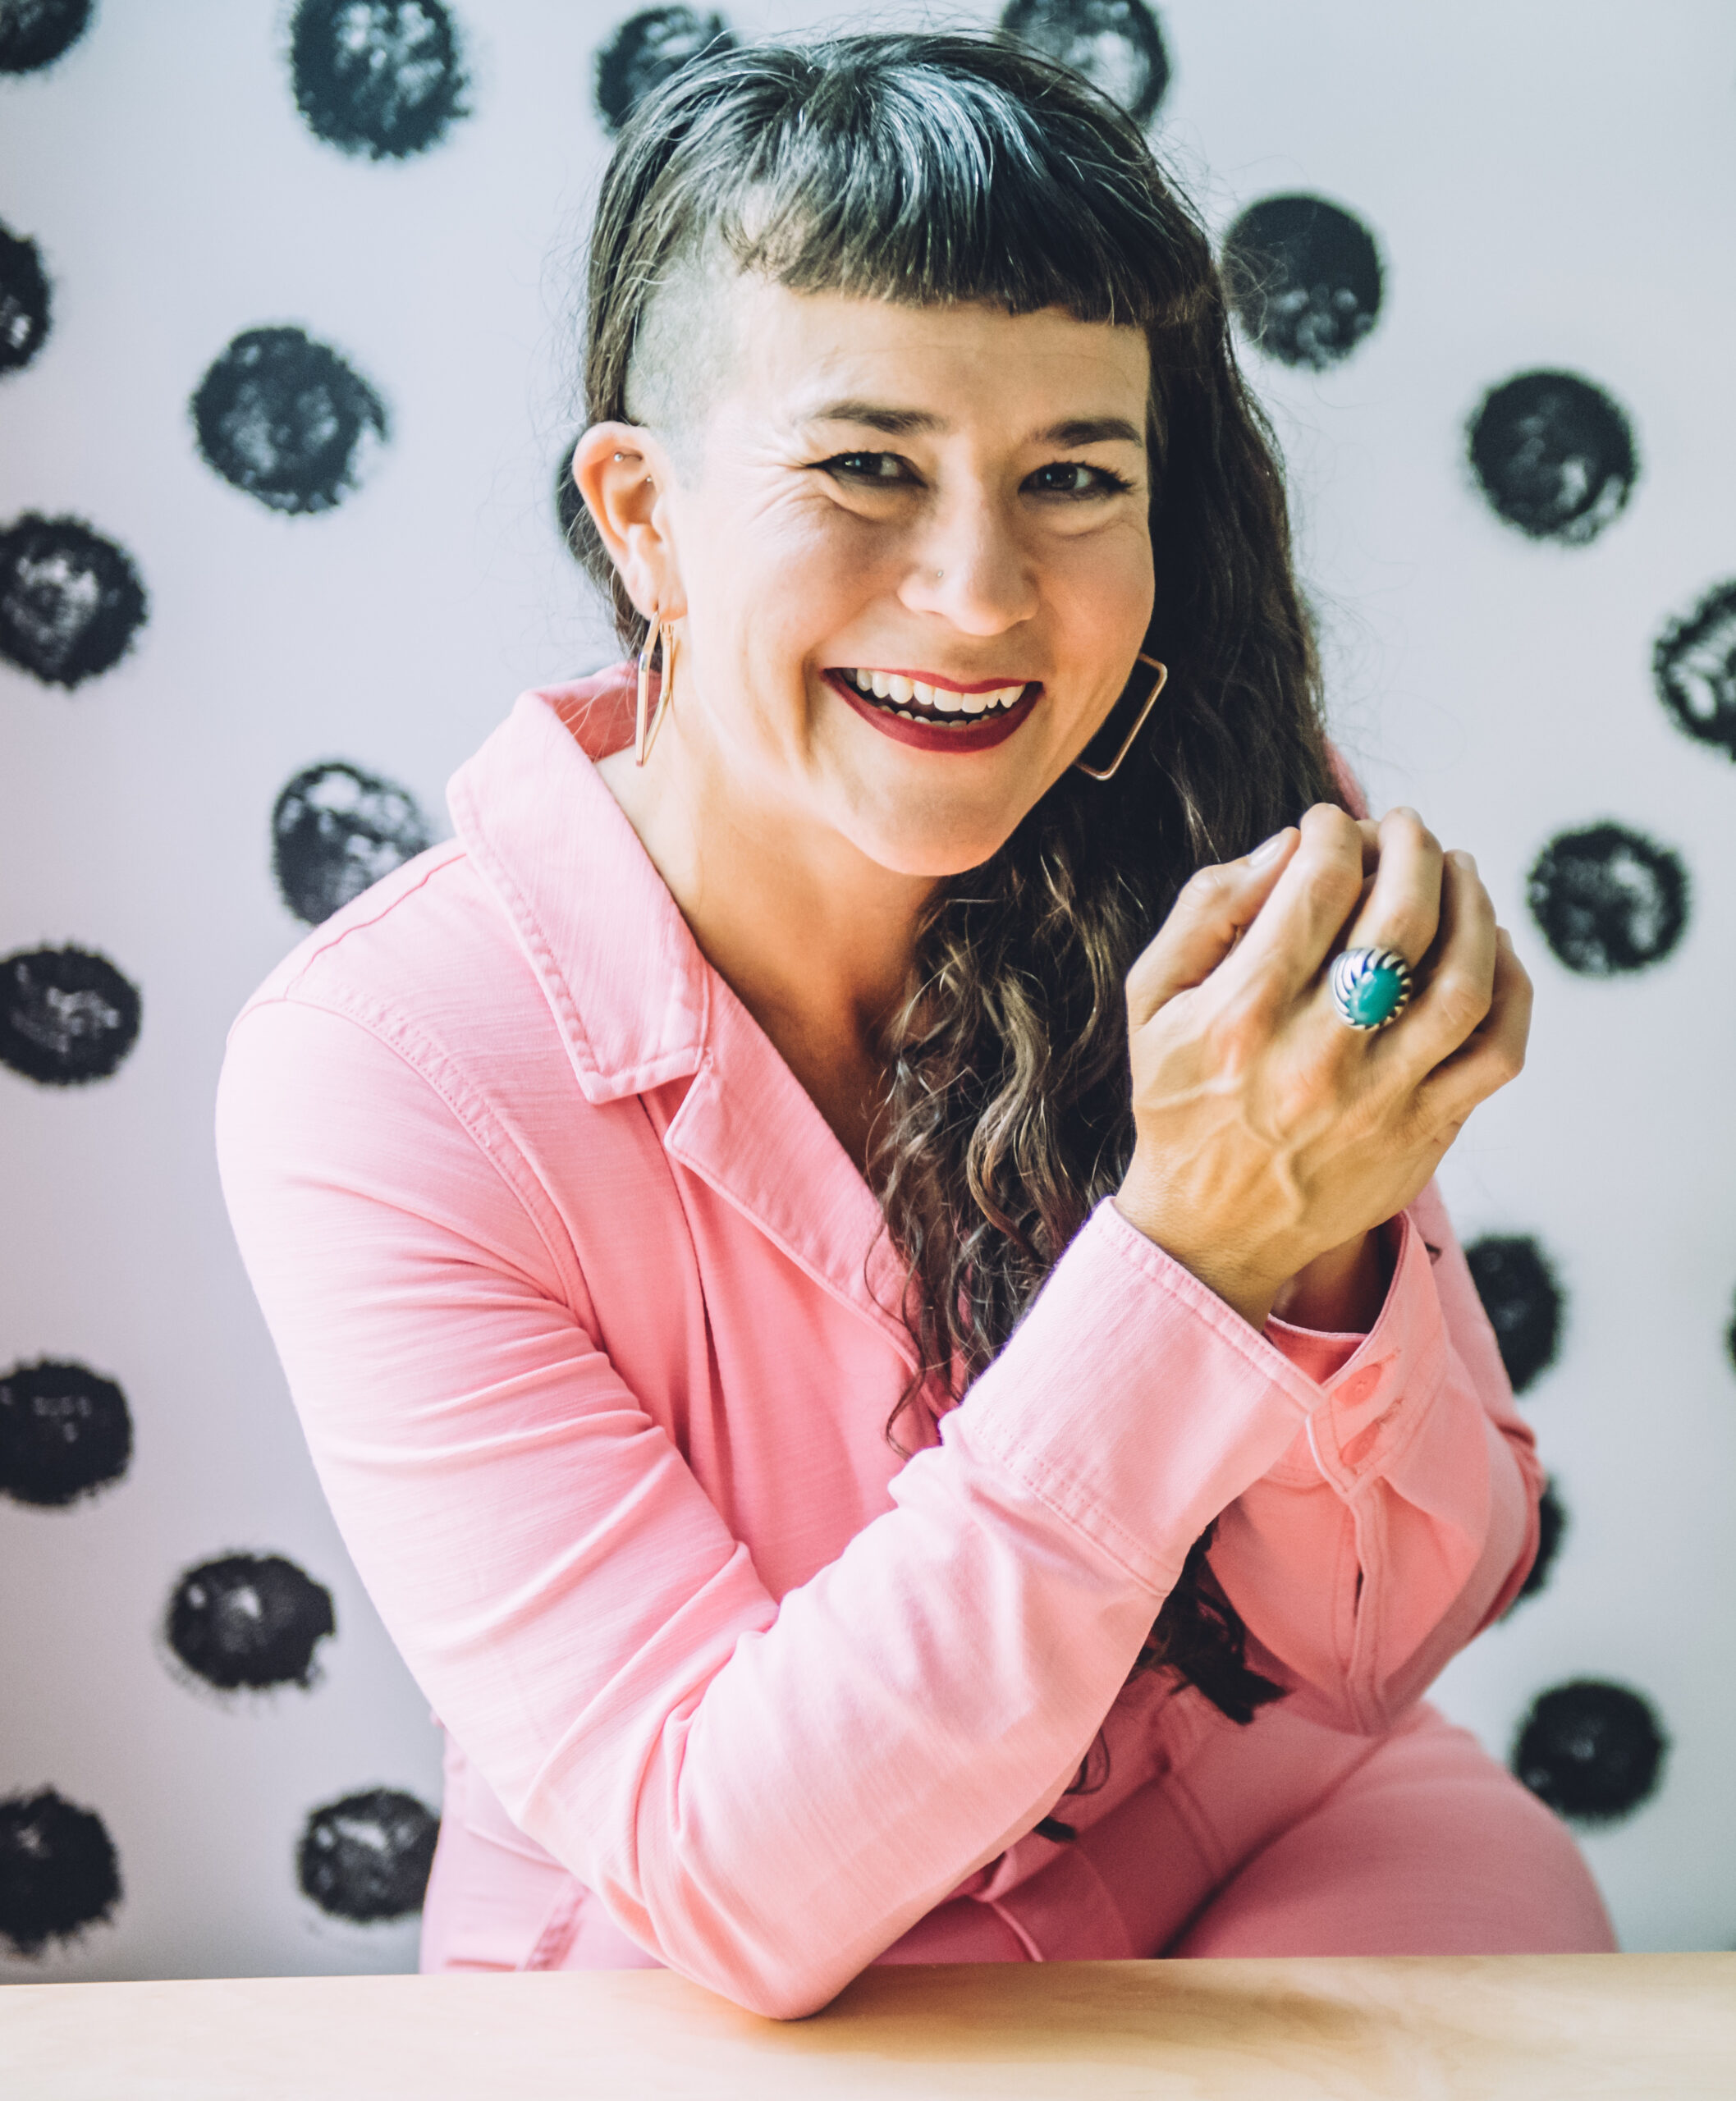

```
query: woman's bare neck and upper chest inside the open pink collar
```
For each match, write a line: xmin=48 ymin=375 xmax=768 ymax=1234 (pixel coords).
xmin=599 ymin=706 xmax=933 ymax=1168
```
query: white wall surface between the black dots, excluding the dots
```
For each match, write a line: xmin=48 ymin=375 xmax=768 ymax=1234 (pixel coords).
xmin=0 ymin=0 xmax=1736 ymax=1977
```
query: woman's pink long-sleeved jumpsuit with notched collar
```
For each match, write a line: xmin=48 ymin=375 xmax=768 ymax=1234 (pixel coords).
xmin=218 ymin=672 xmax=1610 ymax=2015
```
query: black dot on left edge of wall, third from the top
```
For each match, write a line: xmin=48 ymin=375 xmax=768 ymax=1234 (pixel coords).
xmin=0 ymin=510 xmax=149 ymax=689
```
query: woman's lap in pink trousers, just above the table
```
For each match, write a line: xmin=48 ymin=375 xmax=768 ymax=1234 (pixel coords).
xmin=882 ymin=1696 xmax=1614 ymax=1962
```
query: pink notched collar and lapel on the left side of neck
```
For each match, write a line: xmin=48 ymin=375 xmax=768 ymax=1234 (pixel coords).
xmin=447 ymin=664 xmax=916 ymax=1366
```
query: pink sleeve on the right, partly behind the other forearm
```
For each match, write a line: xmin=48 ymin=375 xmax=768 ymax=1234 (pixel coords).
xmin=1211 ymin=1185 xmax=1542 ymax=1733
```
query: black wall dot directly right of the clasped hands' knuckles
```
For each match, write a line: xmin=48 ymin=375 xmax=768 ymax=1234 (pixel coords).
xmin=1526 ymin=824 xmax=1688 ymax=977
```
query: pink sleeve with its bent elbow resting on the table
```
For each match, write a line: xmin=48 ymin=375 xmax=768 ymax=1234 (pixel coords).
xmin=218 ymin=996 xmax=1336 ymax=2015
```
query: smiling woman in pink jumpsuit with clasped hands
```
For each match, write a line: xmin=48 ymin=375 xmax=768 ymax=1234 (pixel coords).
xmin=218 ymin=36 xmax=1610 ymax=2015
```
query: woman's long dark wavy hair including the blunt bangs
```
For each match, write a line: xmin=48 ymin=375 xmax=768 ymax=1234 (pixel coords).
xmin=576 ymin=34 xmax=1339 ymax=1721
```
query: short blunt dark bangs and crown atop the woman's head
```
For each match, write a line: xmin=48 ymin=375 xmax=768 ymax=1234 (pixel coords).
xmin=593 ymin=36 xmax=1208 ymax=365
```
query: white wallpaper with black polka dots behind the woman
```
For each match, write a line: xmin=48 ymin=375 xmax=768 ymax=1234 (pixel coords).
xmin=0 ymin=0 xmax=1736 ymax=1980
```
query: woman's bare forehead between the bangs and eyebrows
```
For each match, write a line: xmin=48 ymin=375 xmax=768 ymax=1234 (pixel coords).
xmin=719 ymin=277 xmax=1150 ymax=439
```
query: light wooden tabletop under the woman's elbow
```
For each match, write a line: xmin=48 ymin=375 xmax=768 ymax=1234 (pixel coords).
xmin=0 ymin=1954 xmax=1736 ymax=2101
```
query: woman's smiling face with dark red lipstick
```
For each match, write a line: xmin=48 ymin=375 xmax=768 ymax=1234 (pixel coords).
xmin=580 ymin=277 xmax=1154 ymax=877
